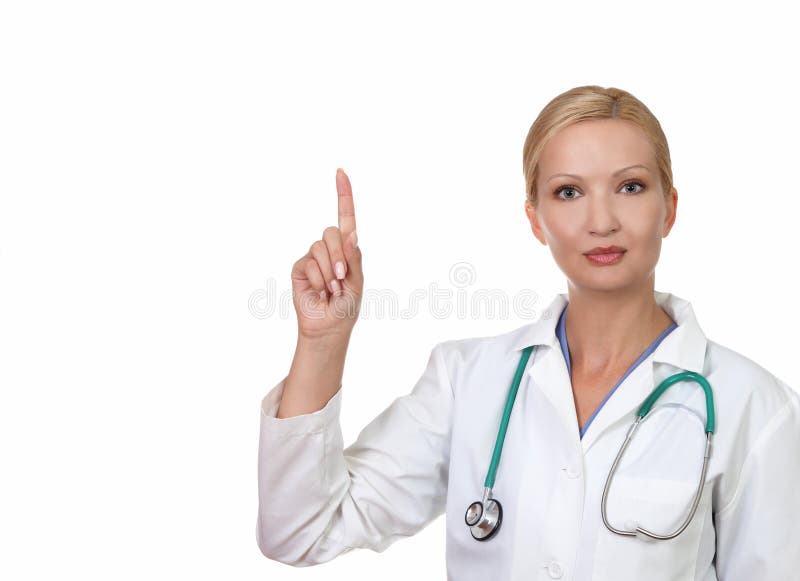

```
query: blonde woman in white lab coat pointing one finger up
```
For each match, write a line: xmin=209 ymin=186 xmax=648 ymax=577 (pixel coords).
xmin=257 ymin=86 xmax=800 ymax=581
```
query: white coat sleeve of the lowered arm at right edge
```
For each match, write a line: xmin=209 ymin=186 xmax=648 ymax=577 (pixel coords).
xmin=715 ymin=388 xmax=800 ymax=581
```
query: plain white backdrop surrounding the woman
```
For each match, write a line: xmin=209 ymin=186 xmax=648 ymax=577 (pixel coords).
xmin=0 ymin=0 xmax=800 ymax=581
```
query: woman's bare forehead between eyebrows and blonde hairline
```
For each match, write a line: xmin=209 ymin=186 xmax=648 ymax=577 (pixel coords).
xmin=539 ymin=119 xmax=656 ymax=179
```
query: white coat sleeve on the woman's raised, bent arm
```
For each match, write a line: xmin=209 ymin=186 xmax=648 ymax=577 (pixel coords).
xmin=256 ymin=343 xmax=453 ymax=567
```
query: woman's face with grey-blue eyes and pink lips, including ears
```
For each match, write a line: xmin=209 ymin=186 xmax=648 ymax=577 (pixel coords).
xmin=525 ymin=119 xmax=678 ymax=291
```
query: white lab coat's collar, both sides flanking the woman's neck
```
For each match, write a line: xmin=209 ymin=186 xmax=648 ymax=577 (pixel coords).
xmin=508 ymin=291 xmax=707 ymax=373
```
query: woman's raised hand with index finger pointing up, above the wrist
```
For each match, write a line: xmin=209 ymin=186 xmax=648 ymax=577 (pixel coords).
xmin=292 ymin=169 xmax=364 ymax=341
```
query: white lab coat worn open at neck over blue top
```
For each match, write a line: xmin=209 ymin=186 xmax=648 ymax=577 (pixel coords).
xmin=256 ymin=291 xmax=800 ymax=581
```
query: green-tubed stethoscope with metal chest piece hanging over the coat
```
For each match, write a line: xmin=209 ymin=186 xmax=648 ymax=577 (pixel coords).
xmin=464 ymin=345 xmax=714 ymax=541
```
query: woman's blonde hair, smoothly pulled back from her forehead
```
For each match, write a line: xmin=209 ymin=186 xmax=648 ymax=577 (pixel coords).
xmin=522 ymin=85 xmax=672 ymax=205
